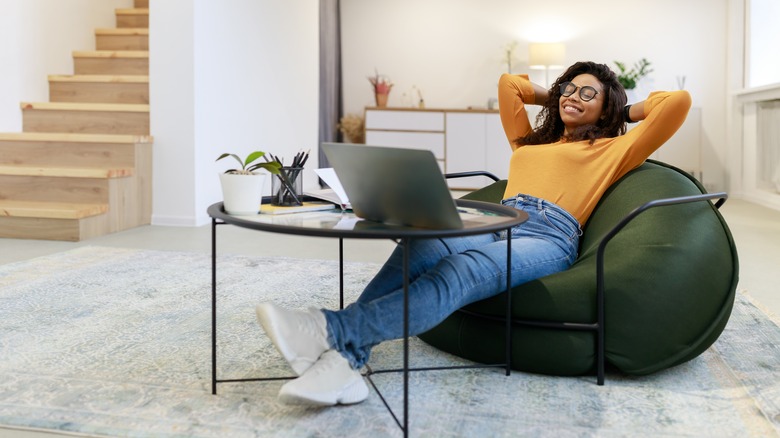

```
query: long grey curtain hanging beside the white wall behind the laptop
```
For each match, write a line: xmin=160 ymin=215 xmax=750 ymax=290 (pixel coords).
xmin=318 ymin=0 xmax=344 ymax=175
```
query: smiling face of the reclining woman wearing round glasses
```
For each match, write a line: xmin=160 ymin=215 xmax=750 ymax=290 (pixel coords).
xmin=558 ymin=73 xmax=604 ymax=135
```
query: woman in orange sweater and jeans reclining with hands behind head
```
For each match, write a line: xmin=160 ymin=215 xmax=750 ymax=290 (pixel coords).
xmin=257 ymin=62 xmax=691 ymax=405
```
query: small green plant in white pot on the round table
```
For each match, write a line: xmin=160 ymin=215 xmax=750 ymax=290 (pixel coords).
xmin=216 ymin=151 xmax=282 ymax=214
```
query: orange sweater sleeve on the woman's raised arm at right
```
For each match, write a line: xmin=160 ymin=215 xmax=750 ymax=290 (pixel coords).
xmin=620 ymin=90 xmax=691 ymax=165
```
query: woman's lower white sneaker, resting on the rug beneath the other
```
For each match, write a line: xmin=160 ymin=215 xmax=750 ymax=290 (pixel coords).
xmin=279 ymin=350 xmax=368 ymax=406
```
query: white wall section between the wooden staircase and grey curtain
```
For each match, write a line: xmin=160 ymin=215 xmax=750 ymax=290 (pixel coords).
xmin=150 ymin=0 xmax=319 ymax=225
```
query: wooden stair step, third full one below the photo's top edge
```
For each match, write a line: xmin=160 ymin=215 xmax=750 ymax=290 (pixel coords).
xmin=73 ymin=50 xmax=149 ymax=75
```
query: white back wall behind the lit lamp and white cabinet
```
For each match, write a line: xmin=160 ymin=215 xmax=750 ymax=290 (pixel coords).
xmin=341 ymin=0 xmax=727 ymax=192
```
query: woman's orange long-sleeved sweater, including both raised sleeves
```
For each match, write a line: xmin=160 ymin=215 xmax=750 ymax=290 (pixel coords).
xmin=498 ymin=74 xmax=691 ymax=224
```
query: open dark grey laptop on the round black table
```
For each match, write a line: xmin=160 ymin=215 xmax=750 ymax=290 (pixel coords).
xmin=322 ymin=143 xmax=463 ymax=229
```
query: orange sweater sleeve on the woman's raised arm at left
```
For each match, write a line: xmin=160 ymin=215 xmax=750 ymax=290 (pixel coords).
xmin=498 ymin=73 xmax=536 ymax=150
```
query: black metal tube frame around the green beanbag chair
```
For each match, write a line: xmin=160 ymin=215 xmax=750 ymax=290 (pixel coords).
xmin=445 ymin=171 xmax=728 ymax=385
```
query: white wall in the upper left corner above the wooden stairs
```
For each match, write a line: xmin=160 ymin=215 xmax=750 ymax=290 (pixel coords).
xmin=0 ymin=0 xmax=132 ymax=132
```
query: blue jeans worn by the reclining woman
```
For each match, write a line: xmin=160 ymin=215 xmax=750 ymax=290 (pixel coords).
xmin=323 ymin=195 xmax=582 ymax=369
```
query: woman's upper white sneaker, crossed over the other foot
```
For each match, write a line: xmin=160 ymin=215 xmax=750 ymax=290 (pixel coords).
xmin=255 ymin=303 xmax=330 ymax=376
